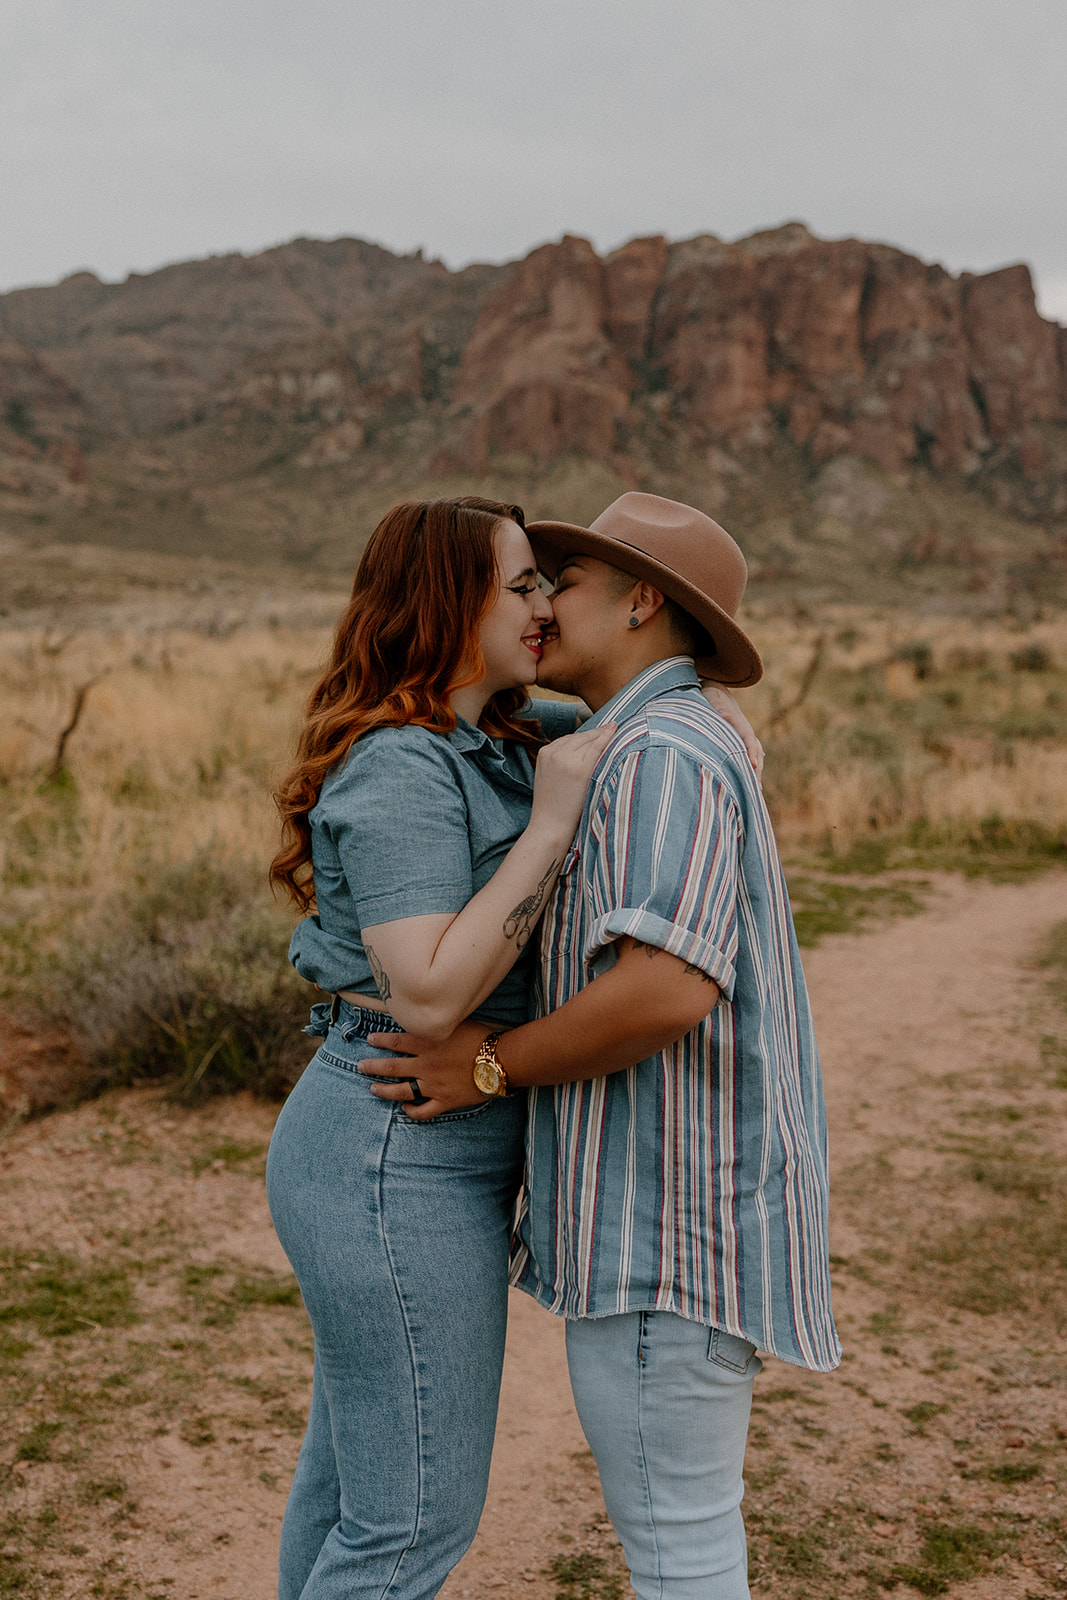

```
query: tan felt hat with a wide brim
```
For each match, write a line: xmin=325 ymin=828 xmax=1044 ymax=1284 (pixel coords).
xmin=526 ymin=491 xmax=763 ymax=688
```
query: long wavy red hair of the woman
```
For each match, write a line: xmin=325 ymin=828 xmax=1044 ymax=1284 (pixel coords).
xmin=270 ymin=494 xmax=541 ymax=910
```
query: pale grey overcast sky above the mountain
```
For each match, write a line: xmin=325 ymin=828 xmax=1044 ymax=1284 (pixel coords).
xmin=0 ymin=0 xmax=1067 ymax=322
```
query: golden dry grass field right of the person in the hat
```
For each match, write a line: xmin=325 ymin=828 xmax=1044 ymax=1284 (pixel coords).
xmin=750 ymin=611 xmax=1067 ymax=859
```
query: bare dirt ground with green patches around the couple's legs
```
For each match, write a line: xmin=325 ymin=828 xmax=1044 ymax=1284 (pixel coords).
xmin=0 ymin=874 xmax=1067 ymax=1600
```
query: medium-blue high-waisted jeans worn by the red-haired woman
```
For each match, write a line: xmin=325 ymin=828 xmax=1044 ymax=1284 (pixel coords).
xmin=267 ymin=1003 xmax=525 ymax=1600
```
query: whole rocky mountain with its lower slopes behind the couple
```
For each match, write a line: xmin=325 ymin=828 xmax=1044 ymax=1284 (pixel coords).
xmin=0 ymin=222 xmax=1067 ymax=601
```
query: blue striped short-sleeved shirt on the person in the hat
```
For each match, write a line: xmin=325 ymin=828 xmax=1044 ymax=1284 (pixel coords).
xmin=512 ymin=658 xmax=840 ymax=1371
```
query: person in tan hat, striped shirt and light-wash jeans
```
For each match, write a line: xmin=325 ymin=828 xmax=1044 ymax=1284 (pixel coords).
xmin=366 ymin=493 xmax=840 ymax=1600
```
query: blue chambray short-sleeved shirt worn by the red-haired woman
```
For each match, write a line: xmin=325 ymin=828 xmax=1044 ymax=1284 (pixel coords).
xmin=290 ymin=701 xmax=577 ymax=1027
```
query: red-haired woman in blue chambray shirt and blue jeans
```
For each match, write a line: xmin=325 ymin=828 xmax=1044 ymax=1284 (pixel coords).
xmin=267 ymin=498 xmax=614 ymax=1600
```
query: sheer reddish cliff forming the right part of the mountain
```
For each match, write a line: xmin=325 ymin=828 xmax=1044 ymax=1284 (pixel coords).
xmin=456 ymin=224 xmax=1067 ymax=508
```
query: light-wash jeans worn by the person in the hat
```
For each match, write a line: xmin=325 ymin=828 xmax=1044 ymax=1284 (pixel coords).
xmin=566 ymin=1310 xmax=761 ymax=1600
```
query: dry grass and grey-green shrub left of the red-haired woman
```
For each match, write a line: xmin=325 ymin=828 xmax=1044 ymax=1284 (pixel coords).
xmin=0 ymin=627 xmax=325 ymax=1101
